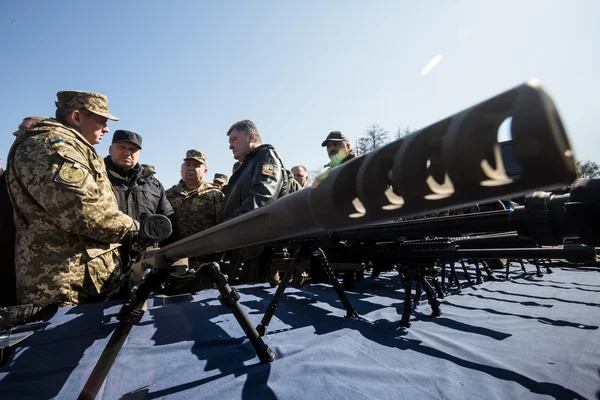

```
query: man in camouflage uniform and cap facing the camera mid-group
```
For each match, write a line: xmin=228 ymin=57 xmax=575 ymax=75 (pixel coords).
xmin=166 ymin=150 xmax=225 ymax=269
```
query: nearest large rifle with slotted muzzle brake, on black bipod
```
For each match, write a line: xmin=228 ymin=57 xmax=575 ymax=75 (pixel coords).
xmin=80 ymin=81 xmax=576 ymax=398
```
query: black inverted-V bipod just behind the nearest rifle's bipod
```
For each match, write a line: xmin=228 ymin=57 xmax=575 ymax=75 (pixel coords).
xmin=256 ymin=245 xmax=358 ymax=336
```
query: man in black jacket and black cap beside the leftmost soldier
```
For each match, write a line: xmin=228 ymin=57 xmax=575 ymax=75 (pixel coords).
xmin=104 ymin=130 xmax=178 ymax=266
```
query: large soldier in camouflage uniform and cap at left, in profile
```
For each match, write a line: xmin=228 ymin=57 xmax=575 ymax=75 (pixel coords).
xmin=6 ymin=91 xmax=137 ymax=306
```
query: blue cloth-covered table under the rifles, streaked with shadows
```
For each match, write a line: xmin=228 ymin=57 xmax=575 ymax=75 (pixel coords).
xmin=0 ymin=267 xmax=600 ymax=400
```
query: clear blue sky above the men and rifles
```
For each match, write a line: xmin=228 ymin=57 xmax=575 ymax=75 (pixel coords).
xmin=0 ymin=0 xmax=600 ymax=187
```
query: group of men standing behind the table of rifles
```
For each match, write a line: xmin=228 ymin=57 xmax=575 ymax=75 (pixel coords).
xmin=0 ymin=91 xmax=356 ymax=306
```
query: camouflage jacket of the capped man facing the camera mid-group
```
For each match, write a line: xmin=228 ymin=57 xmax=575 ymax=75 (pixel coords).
xmin=166 ymin=182 xmax=225 ymax=268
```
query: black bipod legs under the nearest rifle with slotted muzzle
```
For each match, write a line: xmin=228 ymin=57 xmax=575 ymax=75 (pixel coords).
xmin=78 ymin=262 xmax=275 ymax=400
